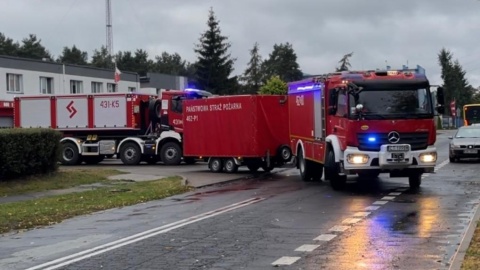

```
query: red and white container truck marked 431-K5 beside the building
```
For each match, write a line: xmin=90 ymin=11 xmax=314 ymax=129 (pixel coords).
xmin=14 ymin=90 xmax=211 ymax=165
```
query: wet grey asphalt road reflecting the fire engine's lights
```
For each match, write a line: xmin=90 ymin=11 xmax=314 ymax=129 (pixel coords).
xmin=0 ymin=130 xmax=480 ymax=269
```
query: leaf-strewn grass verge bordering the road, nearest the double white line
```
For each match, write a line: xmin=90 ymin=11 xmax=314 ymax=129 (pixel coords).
xmin=0 ymin=177 xmax=191 ymax=233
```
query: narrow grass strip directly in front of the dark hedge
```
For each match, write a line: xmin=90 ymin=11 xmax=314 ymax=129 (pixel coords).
xmin=0 ymin=169 xmax=124 ymax=197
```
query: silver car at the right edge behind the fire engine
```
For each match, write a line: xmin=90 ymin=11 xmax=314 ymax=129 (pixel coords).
xmin=448 ymin=124 xmax=480 ymax=163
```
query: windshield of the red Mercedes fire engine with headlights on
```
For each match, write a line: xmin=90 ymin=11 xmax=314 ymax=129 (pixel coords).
xmin=349 ymin=88 xmax=433 ymax=119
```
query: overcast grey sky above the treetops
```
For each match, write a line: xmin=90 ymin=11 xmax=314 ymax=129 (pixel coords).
xmin=0 ymin=0 xmax=480 ymax=87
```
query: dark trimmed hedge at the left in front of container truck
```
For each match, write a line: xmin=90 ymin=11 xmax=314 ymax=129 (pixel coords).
xmin=0 ymin=128 xmax=62 ymax=180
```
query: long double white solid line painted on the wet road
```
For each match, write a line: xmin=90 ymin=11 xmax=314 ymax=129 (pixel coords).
xmin=26 ymin=198 xmax=265 ymax=270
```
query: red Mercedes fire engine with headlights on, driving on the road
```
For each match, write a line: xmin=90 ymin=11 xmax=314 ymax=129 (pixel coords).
xmin=288 ymin=69 xmax=444 ymax=189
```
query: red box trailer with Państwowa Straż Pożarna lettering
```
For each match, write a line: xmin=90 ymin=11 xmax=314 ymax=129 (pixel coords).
xmin=183 ymin=95 xmax=291 ymax=172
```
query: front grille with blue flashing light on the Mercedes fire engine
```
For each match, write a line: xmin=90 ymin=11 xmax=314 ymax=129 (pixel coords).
xmin=357 ymin=132 xmax=428 ymax=151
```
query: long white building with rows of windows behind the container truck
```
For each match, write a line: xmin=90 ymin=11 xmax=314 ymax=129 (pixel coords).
xmin=0 ymin=56 xmax=140 ymax=101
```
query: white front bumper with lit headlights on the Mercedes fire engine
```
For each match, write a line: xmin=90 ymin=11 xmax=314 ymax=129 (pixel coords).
xmin=342 ymin=145 xmax=437 ymax=174
